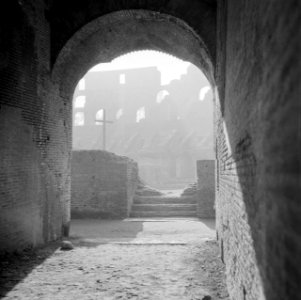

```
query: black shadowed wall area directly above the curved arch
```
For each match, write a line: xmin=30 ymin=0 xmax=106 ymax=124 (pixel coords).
xmin=45 ymin=0 xmax=217 ymax=65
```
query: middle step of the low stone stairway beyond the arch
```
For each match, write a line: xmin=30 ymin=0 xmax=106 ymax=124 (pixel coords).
xmin=132 ymin=203 xmax=196 ymax=212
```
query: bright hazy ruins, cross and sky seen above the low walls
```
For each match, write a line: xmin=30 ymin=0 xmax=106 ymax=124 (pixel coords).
xmin=73 ymin=51 xmax=214 ymax=190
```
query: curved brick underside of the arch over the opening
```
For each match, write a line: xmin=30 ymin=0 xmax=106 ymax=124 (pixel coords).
xmin=52 ymin=10 xmax=214 ymax=99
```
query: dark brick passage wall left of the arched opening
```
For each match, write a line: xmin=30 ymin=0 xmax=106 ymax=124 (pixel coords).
xmin=0 ymin=1 xmax=70 ymax=253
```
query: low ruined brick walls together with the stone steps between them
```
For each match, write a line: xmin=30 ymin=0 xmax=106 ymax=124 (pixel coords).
xmin=71 ymin=150 xmax=215 ymax=219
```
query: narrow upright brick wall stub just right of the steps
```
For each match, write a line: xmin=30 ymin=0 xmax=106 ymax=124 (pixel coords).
xmin=197 ymin=160 xmax=215 ymax=218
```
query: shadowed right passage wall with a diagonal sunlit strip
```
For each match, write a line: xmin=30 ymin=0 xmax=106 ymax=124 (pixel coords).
xmin=216 ymin=0 xmax=301 ymax=300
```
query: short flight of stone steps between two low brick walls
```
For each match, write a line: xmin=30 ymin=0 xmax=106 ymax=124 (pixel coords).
xmin=130 ymin=195 xmax=197 ymax=218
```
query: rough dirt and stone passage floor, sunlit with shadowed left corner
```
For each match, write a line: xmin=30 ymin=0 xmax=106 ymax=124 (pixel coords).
xmin=0 ymin=219 xmax=229 ymax=300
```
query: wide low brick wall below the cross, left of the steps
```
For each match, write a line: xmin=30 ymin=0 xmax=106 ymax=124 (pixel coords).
xmin=71 ymin=150 xmax=138 ymax=218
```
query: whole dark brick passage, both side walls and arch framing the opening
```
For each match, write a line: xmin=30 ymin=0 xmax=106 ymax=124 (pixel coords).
xmin=0 ymin=0 xmax=301 ymax=300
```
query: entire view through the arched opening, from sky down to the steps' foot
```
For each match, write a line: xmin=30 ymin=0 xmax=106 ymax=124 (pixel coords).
xmin=71 ymin=51 xmax=215 ymax=223
